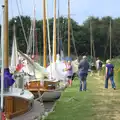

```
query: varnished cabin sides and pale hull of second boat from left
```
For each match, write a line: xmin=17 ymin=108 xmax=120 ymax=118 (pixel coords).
xmin=26 ymin=81 xmax=65 ymax=101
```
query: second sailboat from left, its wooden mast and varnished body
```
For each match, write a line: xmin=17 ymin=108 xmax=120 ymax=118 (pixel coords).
xmin=21 ymin=0 xmax=61 ymax=101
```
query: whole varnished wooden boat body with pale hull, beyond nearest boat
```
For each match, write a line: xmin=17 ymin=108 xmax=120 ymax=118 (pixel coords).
xmin=25 ymin=80 xmax=62 ymax=101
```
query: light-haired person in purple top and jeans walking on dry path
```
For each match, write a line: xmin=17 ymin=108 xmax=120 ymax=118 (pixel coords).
xmin=105 ymin=60 xmax=116 ymax=90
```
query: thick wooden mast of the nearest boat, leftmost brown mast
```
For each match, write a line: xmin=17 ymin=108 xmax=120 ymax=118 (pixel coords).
xmin=4 ymin=0 xmax=9 ymax=68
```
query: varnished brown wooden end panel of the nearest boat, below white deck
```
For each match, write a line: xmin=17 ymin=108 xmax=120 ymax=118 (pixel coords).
xmin=4 ymin=96 xmax=31 ymax=119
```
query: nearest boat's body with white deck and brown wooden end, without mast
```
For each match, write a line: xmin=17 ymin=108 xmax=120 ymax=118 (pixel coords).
xmin=0 ymin=88 xmax=34 ymax=119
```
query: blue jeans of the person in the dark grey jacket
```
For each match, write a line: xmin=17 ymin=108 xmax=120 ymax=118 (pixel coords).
xmin=79 ymin=74 xmax=87 ymax=91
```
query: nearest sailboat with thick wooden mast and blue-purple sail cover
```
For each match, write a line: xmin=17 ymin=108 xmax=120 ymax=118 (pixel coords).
xmin=0 ymin=0 xmax=44 ymax=120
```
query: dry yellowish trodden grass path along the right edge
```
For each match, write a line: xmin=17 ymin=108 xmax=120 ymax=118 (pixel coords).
xmin=93 ymin=74 xmax=120 ymax=120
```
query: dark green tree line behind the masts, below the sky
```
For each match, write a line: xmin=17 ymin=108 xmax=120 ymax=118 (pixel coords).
xmin=0 ymin=16 xmax=120 ymax=59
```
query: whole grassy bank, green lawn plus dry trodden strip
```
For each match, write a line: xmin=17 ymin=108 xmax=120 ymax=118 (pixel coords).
xmin=45 ymin=75 xmax=120 ymax=120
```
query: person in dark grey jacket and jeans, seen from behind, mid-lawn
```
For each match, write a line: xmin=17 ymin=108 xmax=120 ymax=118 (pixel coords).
xmin=78 ymin=56 xmax=89 ymax=91
